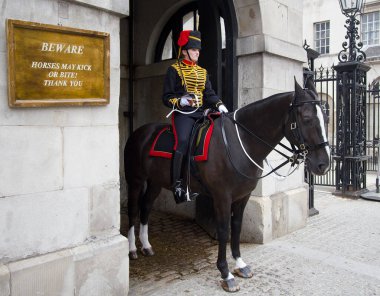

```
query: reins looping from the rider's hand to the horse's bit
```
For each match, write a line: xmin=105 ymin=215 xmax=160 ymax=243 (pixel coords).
xmin=220 ymin=113 xmax=303 ymax=180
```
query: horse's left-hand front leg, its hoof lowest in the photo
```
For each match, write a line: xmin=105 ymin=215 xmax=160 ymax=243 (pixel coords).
xmin=214 ymin=202 xmax=240 ymax=292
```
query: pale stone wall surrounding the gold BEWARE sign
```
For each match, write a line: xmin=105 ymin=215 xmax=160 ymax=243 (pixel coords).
xmin=0 ymin=0 xmax=129 ymax=295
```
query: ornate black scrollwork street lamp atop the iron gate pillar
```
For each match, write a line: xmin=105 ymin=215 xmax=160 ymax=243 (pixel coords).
xmin=338 ymin=0 xmax=366 ymax=63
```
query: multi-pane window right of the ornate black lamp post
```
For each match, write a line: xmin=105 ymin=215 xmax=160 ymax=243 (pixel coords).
xmin=361 ymin=11 xmax=380 ymax=45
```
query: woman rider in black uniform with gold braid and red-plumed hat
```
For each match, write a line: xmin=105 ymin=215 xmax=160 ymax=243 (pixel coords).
xmin=162 ymin=31 xmax=228 ymax=203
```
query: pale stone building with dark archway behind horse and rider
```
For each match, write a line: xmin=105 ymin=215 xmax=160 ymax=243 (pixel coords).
xmin=0 ymin=0 xmax=308 ymax=295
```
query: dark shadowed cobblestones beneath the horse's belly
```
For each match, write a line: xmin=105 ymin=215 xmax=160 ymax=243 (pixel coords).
xmin=121 ymin=211 xmax=217 ymax=282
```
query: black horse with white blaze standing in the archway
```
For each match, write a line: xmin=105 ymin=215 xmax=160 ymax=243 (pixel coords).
xmin=124 ymin=80 xmax=330 ymax=292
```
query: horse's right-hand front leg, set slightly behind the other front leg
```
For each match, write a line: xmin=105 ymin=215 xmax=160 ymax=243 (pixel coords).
xmin=231 ymin=195 xmax=253 ymax=278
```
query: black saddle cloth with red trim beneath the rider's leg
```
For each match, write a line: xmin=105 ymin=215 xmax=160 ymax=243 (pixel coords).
xmin=149 ymin=112 xmax=220 ymax=162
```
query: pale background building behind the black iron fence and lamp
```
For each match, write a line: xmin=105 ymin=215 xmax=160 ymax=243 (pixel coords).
xmin=303 ymin=0 xmax=380 ymax=156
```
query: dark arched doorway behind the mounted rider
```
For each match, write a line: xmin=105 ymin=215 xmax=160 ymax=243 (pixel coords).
xmin=119 ymin=0 xmax=238 ymax=220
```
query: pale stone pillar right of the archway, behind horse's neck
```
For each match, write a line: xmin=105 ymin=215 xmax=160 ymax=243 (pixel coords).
xmin=234 ymin=0 xmax=308 ymax=243
